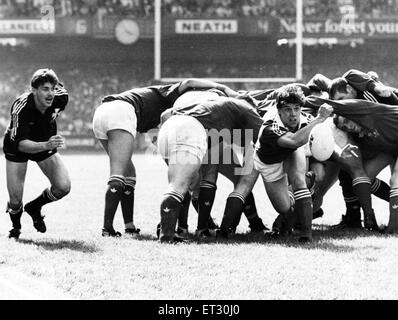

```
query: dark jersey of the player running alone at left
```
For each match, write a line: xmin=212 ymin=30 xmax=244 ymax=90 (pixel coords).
xmin=4 ymin=85 xmax=68 ymax=153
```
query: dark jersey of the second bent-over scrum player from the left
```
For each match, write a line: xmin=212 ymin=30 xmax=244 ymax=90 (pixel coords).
xmin=172 ymin=97 xmax=262 ymax=145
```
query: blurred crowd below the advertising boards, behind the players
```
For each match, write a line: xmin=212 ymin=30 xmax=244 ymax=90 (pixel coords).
xmin=0 ymin=60 xmax=395 ymax=146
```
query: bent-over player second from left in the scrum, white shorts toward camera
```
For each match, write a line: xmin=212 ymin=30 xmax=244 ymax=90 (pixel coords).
xmin=158 ymin=97 xmax=262 ymax=241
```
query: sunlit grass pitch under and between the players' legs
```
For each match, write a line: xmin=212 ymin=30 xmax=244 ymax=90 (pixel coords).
xmin=0 ymin=153 xmax=398 ymax=300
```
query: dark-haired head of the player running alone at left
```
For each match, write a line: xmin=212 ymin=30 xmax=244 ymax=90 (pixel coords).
xmin=30 ymin=69 xmax=59 ymax=108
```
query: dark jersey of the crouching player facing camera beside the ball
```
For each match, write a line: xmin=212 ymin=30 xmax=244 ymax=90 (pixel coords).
xmin=255 ymin=109 xmax=313 ymax=164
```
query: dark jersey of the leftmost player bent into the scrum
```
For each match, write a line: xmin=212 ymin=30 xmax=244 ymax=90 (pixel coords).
xmin=102 ymin=83 xmax=182 ymax=132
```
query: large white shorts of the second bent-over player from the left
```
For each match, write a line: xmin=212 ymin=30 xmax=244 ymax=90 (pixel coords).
xmin=158 ymin=115 xmax=207 ymax=163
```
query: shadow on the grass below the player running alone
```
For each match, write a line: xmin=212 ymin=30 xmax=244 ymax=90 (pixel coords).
xmin=17 ymin=239 xmax=99 ymax=253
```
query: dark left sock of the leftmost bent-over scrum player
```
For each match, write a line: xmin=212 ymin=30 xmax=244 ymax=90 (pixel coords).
xmin=104 ymin=175 xmax=125 ymax=231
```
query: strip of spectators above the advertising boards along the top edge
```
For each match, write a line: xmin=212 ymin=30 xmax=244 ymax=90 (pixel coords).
xmin=0 ymin=0 xmax=398 ymax=18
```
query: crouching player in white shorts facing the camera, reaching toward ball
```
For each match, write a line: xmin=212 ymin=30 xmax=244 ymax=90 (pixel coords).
xmin=254 ymin=85 xmax=333 ymax=242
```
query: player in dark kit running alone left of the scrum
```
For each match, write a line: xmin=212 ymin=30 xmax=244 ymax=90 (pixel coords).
xmin=3 ymin=69 xmax=71 ymax=238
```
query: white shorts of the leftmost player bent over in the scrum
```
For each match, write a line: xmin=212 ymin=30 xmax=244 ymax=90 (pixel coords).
xmin=93 ymin=100 xmax=137 ymax=140
